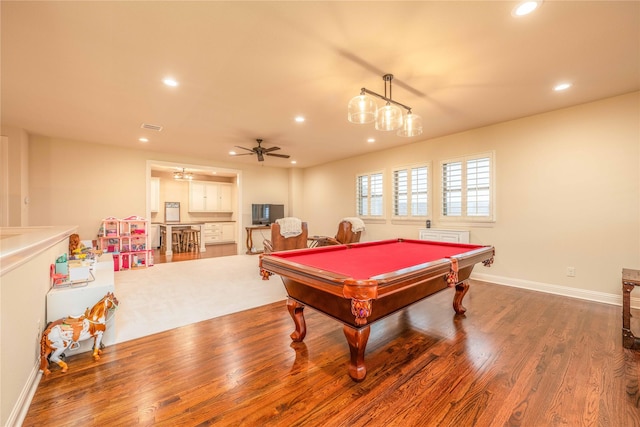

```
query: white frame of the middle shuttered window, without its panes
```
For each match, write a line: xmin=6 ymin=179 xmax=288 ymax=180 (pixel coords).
xmin=391 ymin=163 xmax=431 ymax=221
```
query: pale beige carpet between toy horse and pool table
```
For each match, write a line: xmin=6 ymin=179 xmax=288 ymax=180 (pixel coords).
xmin=115 ymin=255 xmax=287 ymax=343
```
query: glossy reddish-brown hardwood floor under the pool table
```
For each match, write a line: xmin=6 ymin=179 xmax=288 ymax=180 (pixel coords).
xmin=24 ymin=282 xmax=640 ymax=427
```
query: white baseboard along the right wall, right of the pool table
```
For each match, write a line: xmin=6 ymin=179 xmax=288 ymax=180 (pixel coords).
xmin=471 ymin=272 xmax=640 ymax=309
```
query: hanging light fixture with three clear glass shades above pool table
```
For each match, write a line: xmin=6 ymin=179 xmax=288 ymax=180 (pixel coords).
xmin=347 ymin=74 xmax=422 ymax=137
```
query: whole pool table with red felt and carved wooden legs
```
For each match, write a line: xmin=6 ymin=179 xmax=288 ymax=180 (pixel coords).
xmin=259 ymin=239 xmax=495 ymax=381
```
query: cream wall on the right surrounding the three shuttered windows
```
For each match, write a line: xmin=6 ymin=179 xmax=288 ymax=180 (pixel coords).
xmin=304 ymin=92 xmax=640 ymax=295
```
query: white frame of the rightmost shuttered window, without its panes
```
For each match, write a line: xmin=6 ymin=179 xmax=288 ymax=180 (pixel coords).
xmin=439 ymin=151 xmax=496 ymax=224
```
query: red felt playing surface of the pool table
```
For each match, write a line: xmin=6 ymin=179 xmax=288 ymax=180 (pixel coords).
xmin=271 ymin=240 xmax=482 ymax=279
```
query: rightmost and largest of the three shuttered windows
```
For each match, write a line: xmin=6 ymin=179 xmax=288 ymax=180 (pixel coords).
xmin=442 ymin=153 xmax=494 ymax=221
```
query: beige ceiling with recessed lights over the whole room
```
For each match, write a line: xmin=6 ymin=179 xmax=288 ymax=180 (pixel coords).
xmin=0 ymin=0 xmax=640 ymax=167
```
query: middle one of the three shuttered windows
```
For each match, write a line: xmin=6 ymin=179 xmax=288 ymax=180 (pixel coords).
xmin=393 ymin=165 xmax=428 ymax=218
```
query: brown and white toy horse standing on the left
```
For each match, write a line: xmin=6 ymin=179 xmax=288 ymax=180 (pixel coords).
xmin=40 ymin=292 xmax=118 ymax=375
